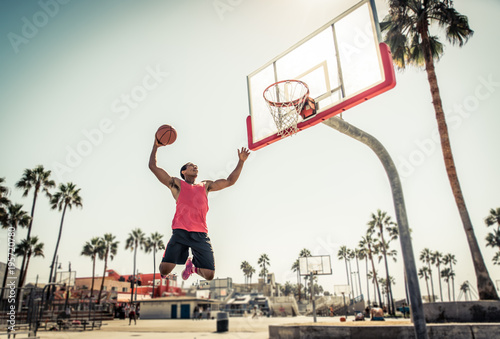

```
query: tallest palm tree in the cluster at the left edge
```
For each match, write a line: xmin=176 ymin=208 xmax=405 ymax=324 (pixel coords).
xmin=16 ymin=165 xmax=56 ymax=287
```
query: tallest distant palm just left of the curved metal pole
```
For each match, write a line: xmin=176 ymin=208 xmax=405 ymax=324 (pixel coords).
xmin=368 ymin=210 xmax=397 ymax=315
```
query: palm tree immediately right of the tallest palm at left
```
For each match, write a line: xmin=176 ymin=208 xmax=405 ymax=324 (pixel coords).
xmin=49 ymin=182 xmax=82 ymax=283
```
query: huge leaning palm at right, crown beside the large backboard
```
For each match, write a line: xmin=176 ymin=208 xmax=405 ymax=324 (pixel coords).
xmin=380 ymin=0 xmax=498 ymax=300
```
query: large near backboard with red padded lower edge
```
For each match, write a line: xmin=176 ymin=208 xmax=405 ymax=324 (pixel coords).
xmin=247 ymin=0 xmax=396 ymax=150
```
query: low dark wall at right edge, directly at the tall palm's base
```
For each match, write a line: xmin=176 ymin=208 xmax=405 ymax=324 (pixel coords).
xmin=423 ymin=300 xmax=500 ymax=323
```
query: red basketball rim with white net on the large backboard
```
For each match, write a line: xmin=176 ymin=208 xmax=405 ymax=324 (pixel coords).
xmin=263 ymin=80 xmax=309 ymax=138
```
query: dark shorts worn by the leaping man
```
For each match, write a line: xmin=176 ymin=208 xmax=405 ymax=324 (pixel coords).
xmin=161 ymin=228 xmax=215 ymax=271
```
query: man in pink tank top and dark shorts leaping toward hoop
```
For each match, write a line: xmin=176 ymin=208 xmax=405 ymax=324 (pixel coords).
xmin=149 ymin=138 xmax=250 ymax=280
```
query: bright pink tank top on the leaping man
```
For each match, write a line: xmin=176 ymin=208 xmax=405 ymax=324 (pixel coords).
xmin=172 ymin=180 xmax=208 ymax=233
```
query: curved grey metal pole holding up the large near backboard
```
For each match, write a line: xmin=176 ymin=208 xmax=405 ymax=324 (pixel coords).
xmin=323 ymin=117 xmax=428 ymax=339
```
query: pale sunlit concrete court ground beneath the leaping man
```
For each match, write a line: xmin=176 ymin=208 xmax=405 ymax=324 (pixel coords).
xmin=37 ymin=316 xmax=410 ymax=339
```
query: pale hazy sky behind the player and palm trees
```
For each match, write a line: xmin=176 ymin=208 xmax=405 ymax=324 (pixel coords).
xmin=0 ymin=0 xmax=500 ymax=297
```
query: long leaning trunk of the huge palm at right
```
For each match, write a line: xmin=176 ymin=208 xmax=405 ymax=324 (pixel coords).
xmin=421 ymin=21 xmax=498 ymax=300
